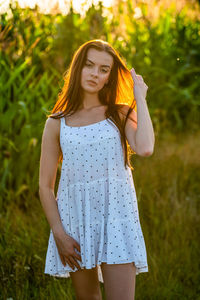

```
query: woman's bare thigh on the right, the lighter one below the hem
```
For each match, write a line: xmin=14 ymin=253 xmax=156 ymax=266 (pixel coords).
xmin=101 ymin=263 xmax=136 ymax=300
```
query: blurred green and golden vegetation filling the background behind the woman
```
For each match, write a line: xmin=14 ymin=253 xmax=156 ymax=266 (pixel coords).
xmin=0 ymin=0 xmax=200 ymax=300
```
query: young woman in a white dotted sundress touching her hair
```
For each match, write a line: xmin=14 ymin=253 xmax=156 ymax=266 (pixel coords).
xmin=39 ymin=39 xmax=154 ymax=300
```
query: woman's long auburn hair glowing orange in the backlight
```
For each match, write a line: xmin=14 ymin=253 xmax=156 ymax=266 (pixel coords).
xmin=48 ymin=39 xmax=137 ymax=169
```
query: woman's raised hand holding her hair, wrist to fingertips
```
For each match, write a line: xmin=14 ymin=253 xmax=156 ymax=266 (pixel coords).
xmin=130 ymin=68 xmax=148 ymax=102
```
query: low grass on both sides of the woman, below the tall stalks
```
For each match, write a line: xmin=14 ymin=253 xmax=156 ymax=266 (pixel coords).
xmin=0 ymin=132 xmax=200 ymax=300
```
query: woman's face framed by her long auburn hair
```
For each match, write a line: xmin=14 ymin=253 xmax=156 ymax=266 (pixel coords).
xmin=81 ymin=48 xmax=113 ymax=93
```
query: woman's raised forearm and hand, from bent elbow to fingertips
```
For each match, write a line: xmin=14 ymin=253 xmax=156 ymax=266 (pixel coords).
xmin=130 ymin=68 xmax=155 ymax=156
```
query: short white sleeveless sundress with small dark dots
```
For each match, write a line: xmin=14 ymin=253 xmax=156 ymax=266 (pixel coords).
xmin=44 ymin=117 xmax=148 ymax=283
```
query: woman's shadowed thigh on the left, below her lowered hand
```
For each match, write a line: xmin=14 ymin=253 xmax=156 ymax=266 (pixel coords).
xmin=70 ymin=266 xmax=102 ymax=300
